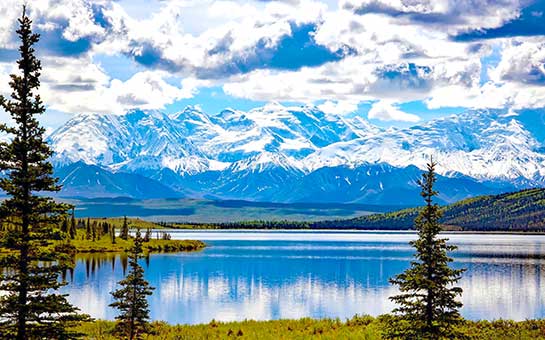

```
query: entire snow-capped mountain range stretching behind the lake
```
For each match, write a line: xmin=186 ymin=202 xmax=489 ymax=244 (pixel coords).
xmin=48 ymin=103 xmax=545 ymax=204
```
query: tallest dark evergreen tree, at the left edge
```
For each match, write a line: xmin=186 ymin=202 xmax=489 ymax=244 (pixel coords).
xmin=0 ymin=7 xmax=89 ymax=339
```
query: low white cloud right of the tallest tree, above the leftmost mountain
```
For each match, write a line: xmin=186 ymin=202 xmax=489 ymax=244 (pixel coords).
xmin=36 ymin=58 xmax=207 ymax=114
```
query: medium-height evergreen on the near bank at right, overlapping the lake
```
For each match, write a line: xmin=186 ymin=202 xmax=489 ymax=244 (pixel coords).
xmin=386 ymin=159 xmax=464 ymax=339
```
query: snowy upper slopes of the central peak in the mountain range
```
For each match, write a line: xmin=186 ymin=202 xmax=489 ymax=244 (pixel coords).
xmin=198 ymin=103 xmax=362 ymax=162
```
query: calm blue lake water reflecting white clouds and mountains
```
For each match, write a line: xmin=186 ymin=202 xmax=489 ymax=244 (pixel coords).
xmin=63 ymin=231 xmax=545 ymax=324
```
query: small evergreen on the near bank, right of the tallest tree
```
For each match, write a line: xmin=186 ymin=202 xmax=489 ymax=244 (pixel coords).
xmin=110 ymin=230 xmax=154 ymax=340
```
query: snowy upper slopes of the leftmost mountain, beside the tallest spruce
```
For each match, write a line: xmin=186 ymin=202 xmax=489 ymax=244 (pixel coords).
xmin=48 ymin=110 xmax=207 ymax=172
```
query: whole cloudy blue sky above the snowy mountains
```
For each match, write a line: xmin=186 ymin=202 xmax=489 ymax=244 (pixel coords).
xmin=0 ymin=0 xmax=545 ymax=129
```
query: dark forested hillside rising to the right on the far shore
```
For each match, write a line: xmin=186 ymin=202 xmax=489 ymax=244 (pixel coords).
xmin=190 ymin=188 xmax=545 ymax=232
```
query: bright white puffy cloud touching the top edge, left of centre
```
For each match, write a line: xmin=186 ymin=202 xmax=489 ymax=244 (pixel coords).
xmin=94 ymin=0 xmax=328 ymax=78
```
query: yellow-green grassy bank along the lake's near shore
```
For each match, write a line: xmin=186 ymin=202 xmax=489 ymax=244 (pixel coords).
xmin=78 ymin=316 xmax=545 ymax=340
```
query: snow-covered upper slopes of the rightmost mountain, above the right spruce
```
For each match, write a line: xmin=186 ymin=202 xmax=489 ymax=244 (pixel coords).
xmin=305 ymin=111 xmax=545 ymax=181
